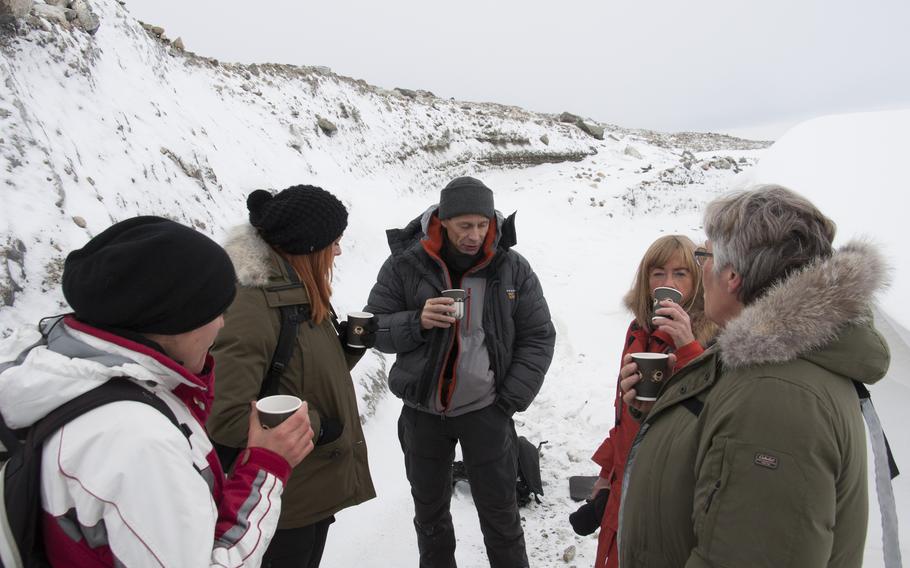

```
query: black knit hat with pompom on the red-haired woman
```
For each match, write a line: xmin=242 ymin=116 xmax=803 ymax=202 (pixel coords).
xmin=246 ymin=185 xmax=348 ymax=254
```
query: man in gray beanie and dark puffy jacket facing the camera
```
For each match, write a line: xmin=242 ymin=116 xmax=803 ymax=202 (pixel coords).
xmin=365 ymin=177 xmax=556 ymax=568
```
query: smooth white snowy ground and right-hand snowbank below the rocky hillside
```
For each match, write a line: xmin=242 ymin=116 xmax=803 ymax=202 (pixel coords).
xmin=325 ymin=117 xmax=910 ymax=568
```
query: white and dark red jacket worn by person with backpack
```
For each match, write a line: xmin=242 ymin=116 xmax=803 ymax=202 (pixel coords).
xmin=0 ymin=317 xmax=290 ymax=567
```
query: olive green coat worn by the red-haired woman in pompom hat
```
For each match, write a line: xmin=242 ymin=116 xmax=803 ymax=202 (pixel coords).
xmin=208 ymin=226 xmax=376 ymax=529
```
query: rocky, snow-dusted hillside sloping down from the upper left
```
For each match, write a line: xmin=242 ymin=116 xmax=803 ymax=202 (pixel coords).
xmin=0 ymin=0 xmax=761 ymax=335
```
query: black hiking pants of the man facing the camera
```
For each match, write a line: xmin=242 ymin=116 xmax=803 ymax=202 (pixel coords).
xmin=398 ymin=405 xmax=528 ymax=568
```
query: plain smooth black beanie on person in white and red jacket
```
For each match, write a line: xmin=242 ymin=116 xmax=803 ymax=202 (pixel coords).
xmin=63 ymin=216 xmax=235 ymax=335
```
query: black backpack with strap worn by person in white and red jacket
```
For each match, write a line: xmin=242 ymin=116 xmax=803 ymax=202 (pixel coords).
xmin=0 ymin=379 xmax=186 ymax=568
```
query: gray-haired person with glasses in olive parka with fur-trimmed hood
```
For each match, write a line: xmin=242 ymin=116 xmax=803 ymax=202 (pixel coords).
xmin=619 ymin=186 xmax=890 ymax=568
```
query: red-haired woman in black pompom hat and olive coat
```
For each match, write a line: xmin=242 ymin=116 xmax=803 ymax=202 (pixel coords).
xmin=208 ymin=185 xmax=376 ymax=568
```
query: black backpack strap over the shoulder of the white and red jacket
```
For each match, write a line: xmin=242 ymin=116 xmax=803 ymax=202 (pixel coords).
xmin=3 ymin=378 xmax=185 ymax=565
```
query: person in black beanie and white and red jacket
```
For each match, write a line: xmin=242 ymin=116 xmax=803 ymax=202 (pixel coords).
xmin=0 ymin=217 xmax=313 ymax=567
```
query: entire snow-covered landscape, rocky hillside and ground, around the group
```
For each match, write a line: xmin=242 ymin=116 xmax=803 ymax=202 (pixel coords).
xmin=0 ymin=0 xmax=910 ymax=568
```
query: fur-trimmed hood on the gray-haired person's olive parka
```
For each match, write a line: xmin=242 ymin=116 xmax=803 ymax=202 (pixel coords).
xmin=718 ymin=241 xmax=890 ymax=380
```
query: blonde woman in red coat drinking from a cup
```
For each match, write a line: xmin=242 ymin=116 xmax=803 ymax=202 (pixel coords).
xmin=572 ymin=235 xmax=716 ymax=568
